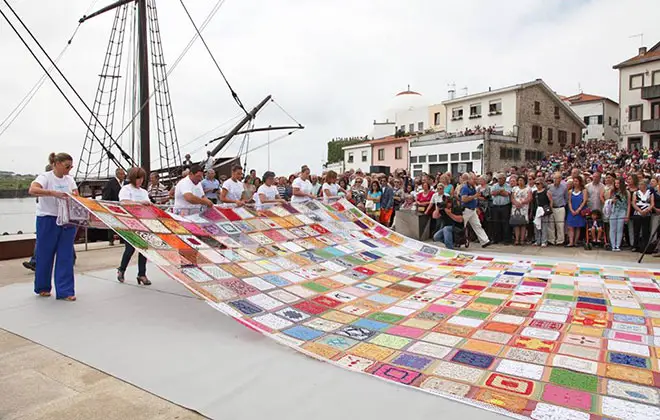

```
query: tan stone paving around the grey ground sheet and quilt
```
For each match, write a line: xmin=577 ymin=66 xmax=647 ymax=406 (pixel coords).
xmin=0 ymin=244 xmax=660 ymax=420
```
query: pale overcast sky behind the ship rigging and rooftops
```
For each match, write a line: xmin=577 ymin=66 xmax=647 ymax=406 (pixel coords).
xmin=0 ymin=0 xmax=660 ymax=173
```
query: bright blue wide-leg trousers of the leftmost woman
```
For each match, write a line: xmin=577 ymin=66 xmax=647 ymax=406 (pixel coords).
xmin=34 ymin=216 xmax=76 ymax=299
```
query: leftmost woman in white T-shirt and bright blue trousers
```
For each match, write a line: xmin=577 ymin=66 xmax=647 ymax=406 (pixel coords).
xmin=29 ymin=153 xmax=78 ymax=301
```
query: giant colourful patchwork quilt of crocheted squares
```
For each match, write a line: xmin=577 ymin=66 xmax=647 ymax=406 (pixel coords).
xmin=75 ymin=197 xmax=660 ymax=420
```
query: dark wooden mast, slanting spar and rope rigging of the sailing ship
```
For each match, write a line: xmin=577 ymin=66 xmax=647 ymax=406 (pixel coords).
xmin=0 ymin=0 xmax=304 ymax=196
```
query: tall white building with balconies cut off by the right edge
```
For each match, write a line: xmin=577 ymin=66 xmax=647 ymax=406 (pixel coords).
xmin=614 ymin=42 xmax=660 ymax=150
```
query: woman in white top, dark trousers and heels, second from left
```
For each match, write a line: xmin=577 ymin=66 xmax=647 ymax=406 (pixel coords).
xmin=117 ymin=168 xmax=151 ymax=286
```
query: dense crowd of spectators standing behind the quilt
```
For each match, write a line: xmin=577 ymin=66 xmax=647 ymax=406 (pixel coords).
xmin=156 ymin=141 xmax=660 ymax=255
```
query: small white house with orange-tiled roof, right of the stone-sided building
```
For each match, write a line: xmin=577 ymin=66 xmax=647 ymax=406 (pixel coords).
xmin=564 ymin=93 xmax=619 ymax=141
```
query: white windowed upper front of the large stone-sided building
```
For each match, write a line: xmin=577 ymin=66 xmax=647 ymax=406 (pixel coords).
xmin=442 ymin=86 xmax=517 ymax=134
